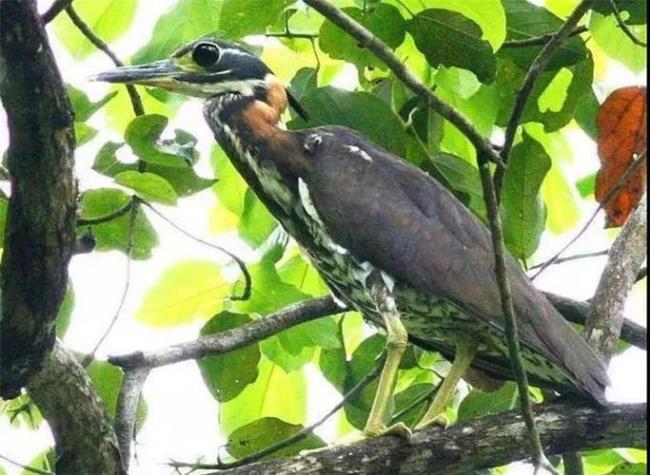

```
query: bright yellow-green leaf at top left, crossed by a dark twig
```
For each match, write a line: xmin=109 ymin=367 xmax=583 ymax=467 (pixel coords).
xmin=53 ymin=0 xmax=138 ymax=59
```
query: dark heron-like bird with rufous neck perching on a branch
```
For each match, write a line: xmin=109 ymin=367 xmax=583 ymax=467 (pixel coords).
xmin=96 ymin=38 xmax=608 ymax=435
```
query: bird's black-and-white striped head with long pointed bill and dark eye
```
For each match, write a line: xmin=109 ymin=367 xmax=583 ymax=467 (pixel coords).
xmin=93 ymin=38 xmax=306 ymax=117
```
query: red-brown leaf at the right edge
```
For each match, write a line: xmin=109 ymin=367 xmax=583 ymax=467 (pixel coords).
xmin=595 ymin=86 xmax=647 ymax=228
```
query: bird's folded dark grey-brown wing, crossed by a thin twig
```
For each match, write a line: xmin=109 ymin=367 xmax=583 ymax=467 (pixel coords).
xmin=305 ymin=127 xmax=608 ymax=402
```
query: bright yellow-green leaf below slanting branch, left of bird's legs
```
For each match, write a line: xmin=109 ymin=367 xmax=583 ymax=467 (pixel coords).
xmin=219 ymin=357 xmax=307 ymax=435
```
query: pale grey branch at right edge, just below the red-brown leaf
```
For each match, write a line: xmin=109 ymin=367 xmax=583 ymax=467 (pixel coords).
xmin=586 ymin=195 xmax=648 ymax=360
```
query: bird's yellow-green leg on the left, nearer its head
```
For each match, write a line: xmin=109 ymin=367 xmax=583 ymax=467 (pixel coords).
xmin=364 ymin=278 xmax=411 ymax=437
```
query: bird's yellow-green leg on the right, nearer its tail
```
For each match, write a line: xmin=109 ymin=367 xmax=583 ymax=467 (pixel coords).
xmin=415 ymin=341 xmax=476 ymax=430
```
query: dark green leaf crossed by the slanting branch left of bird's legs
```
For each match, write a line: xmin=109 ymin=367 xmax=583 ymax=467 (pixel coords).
xmin=197 ymin=312 xmax=260 ymax=402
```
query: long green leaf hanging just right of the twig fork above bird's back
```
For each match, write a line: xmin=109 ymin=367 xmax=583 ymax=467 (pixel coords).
xmin=501 ymin=132 xmax=551 ymax=259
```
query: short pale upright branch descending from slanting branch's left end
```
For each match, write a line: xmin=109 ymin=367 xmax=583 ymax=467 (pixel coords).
xmin=115 ymin=368 xmax=149 ymax=472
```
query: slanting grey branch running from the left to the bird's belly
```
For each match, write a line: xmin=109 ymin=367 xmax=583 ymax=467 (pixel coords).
xmin=109 ymin=297 xmax=343 ymax=369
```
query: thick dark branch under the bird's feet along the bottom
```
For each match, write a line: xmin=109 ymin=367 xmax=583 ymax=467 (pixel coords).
xmin=211 ymin=403 xmax=647 ymax=475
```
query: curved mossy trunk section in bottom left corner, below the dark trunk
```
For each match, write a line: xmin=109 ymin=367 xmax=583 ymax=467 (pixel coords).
xmin=27 ymin=343 xmax=125 ymax=475
